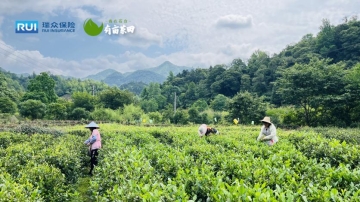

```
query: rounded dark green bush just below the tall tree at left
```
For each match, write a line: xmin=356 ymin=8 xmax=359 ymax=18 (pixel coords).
xmin=19 ymin=100 xmax=46 ymax=119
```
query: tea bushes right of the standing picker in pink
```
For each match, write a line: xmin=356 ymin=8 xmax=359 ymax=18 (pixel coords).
xmin=83 ymin=126 xmax=360 ymax=201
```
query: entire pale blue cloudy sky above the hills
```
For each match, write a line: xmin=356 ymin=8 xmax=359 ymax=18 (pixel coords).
xmin=0 ymin=0 xmax=360 ymax=77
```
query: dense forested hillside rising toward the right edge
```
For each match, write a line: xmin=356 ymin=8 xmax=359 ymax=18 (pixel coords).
xmin=139 ymin=18 xmax=360 ymax=125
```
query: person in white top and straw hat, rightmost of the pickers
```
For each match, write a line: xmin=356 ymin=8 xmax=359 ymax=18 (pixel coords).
xmin=257 ymin=116 xmax=279 ymax=146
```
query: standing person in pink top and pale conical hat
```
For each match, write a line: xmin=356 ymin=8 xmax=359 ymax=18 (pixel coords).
xmin=84 ymin=121 xmax=101 ymax=175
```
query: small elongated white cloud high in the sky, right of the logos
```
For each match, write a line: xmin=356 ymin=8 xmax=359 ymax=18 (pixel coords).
xmin=215 ymin=15 xmax=252 ymax=29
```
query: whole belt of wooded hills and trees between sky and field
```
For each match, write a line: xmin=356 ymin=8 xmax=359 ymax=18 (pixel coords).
xmin=0 ymin=17 xmax=360 ymax=127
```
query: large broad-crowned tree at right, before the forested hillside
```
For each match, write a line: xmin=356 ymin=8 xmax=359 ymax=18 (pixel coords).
xmin=277 ymin=58 xmax=346 ymax=125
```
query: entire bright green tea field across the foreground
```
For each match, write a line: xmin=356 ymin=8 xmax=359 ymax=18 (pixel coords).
xmin=0 ymin=124 xmax=360 ymax=201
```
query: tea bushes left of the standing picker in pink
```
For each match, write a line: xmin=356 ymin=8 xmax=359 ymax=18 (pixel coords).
xmin=0 ymin=131 xmax=86 ymax=201
